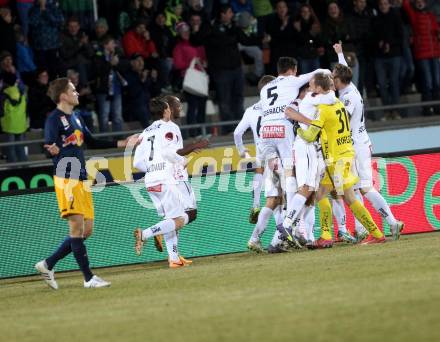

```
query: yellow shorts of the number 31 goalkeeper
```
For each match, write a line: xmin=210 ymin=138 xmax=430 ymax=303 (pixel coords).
xmin=321 ymin=157 xmax=359 ymax=195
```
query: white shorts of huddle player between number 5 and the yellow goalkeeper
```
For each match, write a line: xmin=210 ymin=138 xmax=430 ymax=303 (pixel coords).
xmin=294 ymin=137 xmax=321 ymax=190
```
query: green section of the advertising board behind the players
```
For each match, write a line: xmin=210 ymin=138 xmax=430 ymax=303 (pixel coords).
xmin=0 ymin=172 xmax=274 ymax=278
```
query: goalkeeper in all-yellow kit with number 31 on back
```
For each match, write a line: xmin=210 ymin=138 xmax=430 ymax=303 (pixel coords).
xmin=287 ymin=73 xmax=385 ymax=247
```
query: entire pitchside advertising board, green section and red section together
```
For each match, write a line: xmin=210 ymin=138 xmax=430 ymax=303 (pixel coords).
xmin=0 ymin=153 xmax=440 ymax=278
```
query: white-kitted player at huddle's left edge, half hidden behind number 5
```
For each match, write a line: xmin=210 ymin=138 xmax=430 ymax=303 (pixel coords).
xmin=234 ymin=75 xmax=275 ymax=224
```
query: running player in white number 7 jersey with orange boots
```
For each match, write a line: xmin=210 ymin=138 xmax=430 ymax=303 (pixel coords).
xmin=133 ymin=98 xmax=189 ymax=268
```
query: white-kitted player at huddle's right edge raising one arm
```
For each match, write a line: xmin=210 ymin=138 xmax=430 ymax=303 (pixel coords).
xmin=333 ymin=44 xmax=404 ymax=240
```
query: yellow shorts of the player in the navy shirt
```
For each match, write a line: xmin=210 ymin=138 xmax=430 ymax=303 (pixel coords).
xmin=53 ymin=176 xmax=95 ymax=219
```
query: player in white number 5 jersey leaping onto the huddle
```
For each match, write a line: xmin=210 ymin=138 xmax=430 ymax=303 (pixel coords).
xmin=260 ymin=57 xmax=329 ymax=243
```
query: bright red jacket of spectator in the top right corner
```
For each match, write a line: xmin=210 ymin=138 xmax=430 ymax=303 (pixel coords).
xmin=403 ymin=0 xmax=440 ymax=60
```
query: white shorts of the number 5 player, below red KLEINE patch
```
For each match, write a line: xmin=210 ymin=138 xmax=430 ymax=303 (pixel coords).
xmin=259 ymin=120 xmax=294 ymax=169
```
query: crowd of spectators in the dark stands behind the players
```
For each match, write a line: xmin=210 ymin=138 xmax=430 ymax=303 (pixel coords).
xmin=0 ymin=0 xmax=440 ymax=161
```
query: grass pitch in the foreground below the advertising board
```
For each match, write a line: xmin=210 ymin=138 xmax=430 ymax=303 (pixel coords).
xmin=0 ymin=233 xmax=440 ymax=342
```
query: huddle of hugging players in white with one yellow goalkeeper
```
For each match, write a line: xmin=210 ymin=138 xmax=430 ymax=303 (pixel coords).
xmin=234 ymin=44 xmax=404 ymax=253
